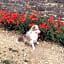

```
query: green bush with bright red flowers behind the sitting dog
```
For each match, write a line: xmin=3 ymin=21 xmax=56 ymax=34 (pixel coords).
xmin=0 ymin=9 xmax=64 ymax=46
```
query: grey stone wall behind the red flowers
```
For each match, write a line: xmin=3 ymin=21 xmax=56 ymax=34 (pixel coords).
xmin=0 ymin=0 xmax=64 ymax=19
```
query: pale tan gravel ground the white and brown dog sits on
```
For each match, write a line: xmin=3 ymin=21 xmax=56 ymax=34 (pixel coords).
xmin=0 ymin=29 xmax=64 ymax=64
